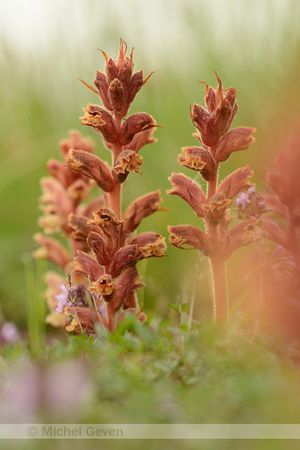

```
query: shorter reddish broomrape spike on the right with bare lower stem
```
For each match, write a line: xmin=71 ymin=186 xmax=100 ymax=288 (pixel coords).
xmin=167 ymin=71 xmax=256 ymax=320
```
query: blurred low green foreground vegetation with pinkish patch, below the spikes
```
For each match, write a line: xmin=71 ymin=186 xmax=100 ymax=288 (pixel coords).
xmin=0 ymin=314 xmax=300 ymax=450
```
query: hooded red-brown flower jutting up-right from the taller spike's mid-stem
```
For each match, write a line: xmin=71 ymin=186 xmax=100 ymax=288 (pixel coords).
xmin=123 ymin=190 xmax=162 ymax=235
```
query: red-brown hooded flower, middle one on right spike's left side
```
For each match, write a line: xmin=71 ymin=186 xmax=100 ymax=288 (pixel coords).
xmin=167 ymin=173 xmax=206 ymax=217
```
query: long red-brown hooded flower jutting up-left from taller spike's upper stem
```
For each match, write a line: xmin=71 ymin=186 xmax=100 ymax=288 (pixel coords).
xmin=68 ymin=150 xmax=114 ymax=192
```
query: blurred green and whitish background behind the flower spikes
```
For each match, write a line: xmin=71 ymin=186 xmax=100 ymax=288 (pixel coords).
xmin=0 ymin=0 xmax=300 ymax=327
